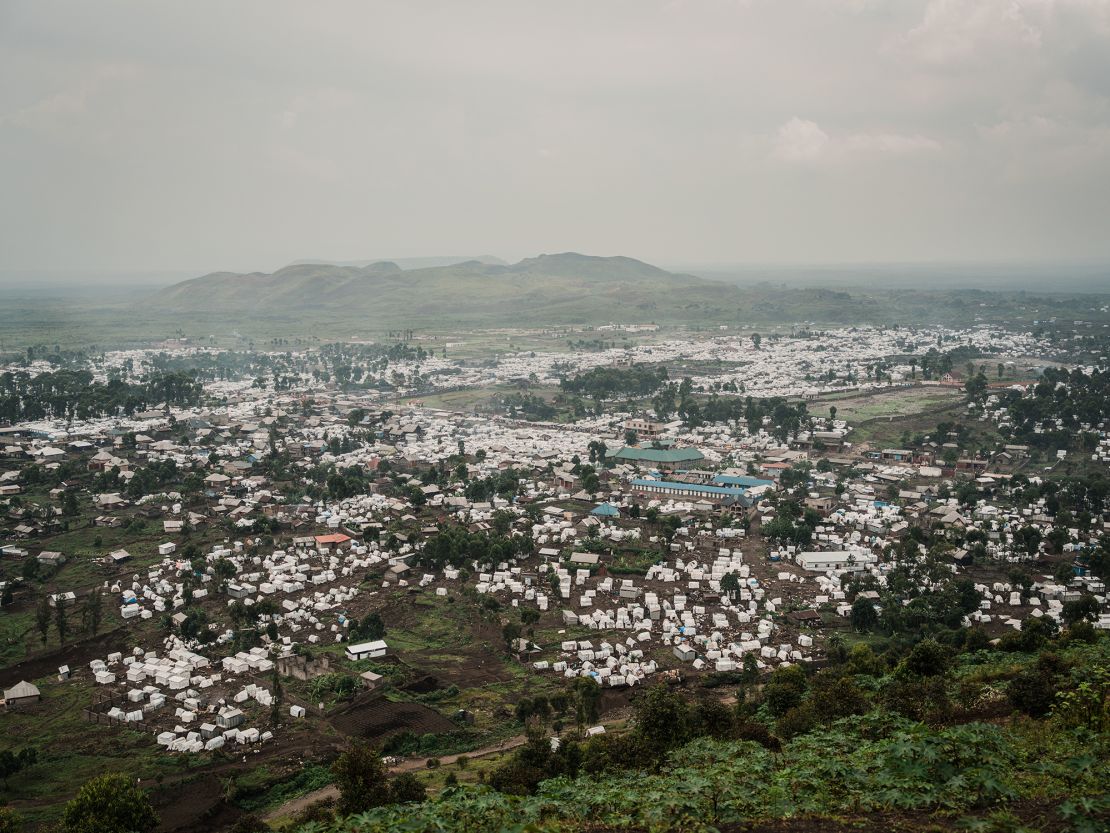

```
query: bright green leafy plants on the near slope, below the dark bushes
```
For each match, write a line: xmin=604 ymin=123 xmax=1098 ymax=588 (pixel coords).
xmin=290 ymin=714 xmax=1110 ymax=833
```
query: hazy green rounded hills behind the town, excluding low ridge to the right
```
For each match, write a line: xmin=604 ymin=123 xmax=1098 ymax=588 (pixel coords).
xmin=144 ymin=252 xmax=740 ymax=325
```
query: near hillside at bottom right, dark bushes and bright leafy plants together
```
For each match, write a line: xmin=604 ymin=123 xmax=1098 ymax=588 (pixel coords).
xmin=286 ymin=624 xmax=1110 ymax=833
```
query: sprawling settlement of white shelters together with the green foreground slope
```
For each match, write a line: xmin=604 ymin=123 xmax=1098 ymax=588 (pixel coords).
xmin=0 ymin=295 xmax=1110 ymax=831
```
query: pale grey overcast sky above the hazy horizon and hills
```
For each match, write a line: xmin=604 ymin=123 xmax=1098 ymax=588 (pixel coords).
xmin=0 ymin=0 xmax=1110 ymax=272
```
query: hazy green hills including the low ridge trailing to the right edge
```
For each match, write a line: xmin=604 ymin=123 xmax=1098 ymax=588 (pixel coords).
xmin=147 ymin=252 xmax=1107 ymax=338
